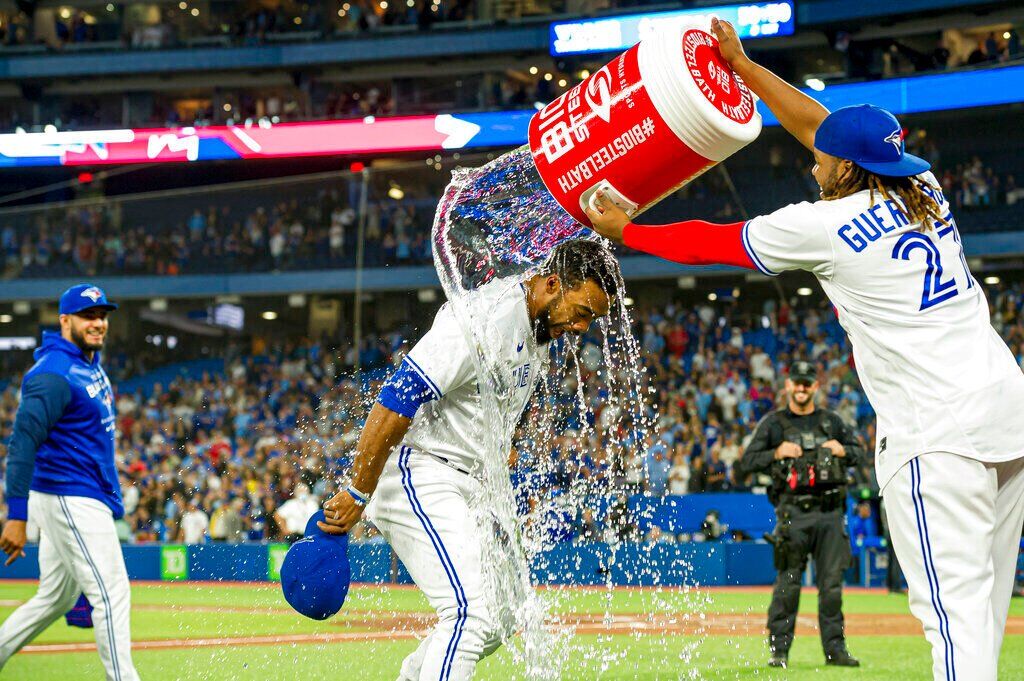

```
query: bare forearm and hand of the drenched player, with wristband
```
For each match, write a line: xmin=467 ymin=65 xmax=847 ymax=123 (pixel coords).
xmin=316 ymin=402 xmax=413 ymax=535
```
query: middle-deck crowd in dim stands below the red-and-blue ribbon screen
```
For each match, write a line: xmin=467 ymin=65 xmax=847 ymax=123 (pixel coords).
xmin=6 ymin=143 xmax=1024 ymax=278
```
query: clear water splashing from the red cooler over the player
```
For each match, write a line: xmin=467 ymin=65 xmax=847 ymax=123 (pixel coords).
xmin=433 ymin=146 xmax=671 ymax=679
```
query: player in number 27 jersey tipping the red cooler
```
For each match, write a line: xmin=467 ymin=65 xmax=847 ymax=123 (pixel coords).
xmin=588 ymin=19 xmax=1024 ymax=681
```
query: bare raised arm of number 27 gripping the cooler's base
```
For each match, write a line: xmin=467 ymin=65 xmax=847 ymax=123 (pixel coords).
xmin=711 ymin=18 xmax=828 ymax=150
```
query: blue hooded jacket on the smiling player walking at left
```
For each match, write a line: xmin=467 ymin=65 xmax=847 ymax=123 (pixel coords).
xmin=6 ymin=332 xmax=124 ymax=520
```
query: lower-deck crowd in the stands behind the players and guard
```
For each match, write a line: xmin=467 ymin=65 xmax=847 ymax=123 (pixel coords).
xmin=0 ymin=285 xmax=1024 ymax=543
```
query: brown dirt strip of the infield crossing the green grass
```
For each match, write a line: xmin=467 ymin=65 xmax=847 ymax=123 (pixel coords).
xmin=24 ymin=606 xmax=1024 ymax=654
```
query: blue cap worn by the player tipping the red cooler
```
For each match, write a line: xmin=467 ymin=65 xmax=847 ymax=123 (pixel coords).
xmin=814 ymin=104 xmax=932 ymax=177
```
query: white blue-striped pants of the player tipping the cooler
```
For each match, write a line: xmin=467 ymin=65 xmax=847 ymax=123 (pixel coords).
xmin=883 ymin=452 xmax=1024 ymax=681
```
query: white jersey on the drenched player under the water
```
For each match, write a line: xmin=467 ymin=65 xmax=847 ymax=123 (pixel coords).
xmin=402 ymin=279 xmax=548 ymax=471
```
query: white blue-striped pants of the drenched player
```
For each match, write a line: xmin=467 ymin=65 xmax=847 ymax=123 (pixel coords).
xmin=367 ymin=446 xmax=501 ymax=681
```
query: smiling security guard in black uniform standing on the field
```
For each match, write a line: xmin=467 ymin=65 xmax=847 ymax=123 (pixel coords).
xmin=736 ymin=361 xmax=863 ymax=668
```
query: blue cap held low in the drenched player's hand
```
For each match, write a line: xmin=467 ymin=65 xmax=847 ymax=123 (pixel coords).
xmin=281 ymin=511 xmax=351 ymax=620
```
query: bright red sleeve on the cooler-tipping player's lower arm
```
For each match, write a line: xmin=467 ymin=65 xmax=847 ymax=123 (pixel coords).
xmin=623 ymin=220 xmax=758 ymax=269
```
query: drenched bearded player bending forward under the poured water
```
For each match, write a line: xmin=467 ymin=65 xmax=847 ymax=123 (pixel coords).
xmin=317 ymin=241 xmax=620 ymax=681
